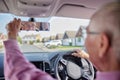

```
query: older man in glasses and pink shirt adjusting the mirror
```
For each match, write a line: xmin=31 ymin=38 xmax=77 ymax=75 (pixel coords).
xmin=4 ymin=3 xmax=120 ymax=80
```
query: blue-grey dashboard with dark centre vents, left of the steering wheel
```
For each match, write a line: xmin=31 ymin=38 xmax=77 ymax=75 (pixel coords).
xmin=0 ymin=52 xmax=63 ymax=80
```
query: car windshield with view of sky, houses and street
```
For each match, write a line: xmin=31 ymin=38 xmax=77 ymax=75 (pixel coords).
xmin=0 ymin=13 xmax=89 ymax=53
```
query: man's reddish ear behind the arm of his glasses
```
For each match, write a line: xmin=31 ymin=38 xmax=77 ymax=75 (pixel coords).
xmin=99 ymin=33 xmax=109 ymax=58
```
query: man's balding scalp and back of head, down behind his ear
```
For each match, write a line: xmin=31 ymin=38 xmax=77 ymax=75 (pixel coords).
xmin=89 ymin=2 xmax=120 ymax=60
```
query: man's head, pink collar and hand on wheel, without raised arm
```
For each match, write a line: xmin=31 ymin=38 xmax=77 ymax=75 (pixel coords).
xmin=74 ymin=3 xmax=120 ymax=80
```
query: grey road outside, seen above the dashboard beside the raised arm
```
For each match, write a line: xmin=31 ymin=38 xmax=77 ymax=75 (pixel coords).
xmin=0 ymin=44 xmax=45 ymax=53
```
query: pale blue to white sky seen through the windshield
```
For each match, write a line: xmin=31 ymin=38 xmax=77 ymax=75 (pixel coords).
xmin=0 ymin=14 xmax=89 ymax=37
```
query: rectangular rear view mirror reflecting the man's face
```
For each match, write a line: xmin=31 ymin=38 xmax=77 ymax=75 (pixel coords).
xmin=20 ymin=21 xmax=50 ymax=31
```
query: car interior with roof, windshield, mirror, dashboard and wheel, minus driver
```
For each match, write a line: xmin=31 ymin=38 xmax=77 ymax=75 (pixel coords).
xmin=0 ymin=0 xmax=115 ymax=80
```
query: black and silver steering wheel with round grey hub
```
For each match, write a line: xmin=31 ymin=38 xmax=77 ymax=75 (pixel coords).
xmin=55 ymin=51 xmax=94 ymax=80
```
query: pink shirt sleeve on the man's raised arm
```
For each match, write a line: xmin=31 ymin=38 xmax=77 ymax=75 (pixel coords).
xmin=4 ymin=40 xmax=55 ymax=80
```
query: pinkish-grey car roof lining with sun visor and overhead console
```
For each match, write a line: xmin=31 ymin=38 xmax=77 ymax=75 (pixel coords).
xmin=0 ymin=0 xmax=115 ymax=19
